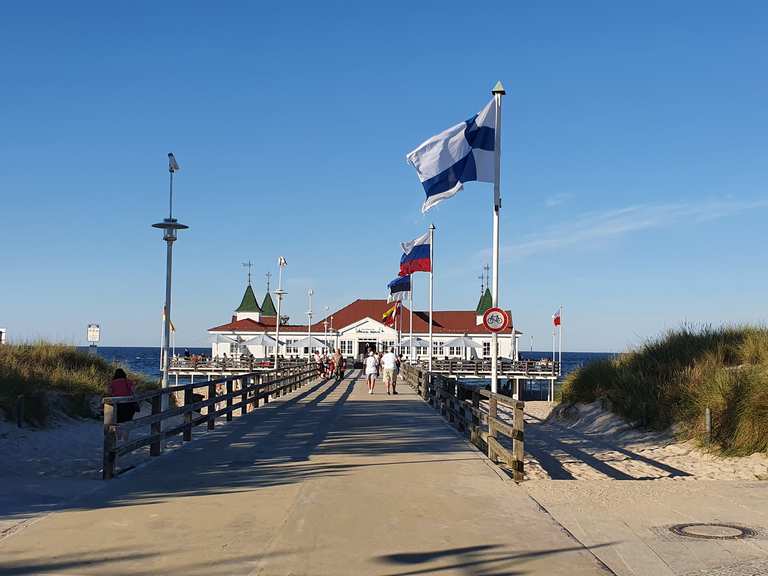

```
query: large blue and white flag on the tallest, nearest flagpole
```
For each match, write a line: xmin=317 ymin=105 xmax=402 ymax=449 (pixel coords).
xmin=406 ymin=100 xmax=496 ymax=212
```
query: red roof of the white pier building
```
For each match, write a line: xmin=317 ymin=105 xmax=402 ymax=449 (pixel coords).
xmin=209 ymin=299 xmax=512 ymax=334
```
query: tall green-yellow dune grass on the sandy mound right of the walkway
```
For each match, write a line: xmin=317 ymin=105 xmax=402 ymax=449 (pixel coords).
xmin=563 ymin=326 xmax=768 ymax=455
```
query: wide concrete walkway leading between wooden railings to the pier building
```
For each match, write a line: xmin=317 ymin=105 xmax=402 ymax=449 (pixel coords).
xmin=0 ymin=371 xmax=614 ymax=576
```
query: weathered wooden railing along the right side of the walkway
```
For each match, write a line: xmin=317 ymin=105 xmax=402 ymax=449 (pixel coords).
xmin=401 ymin=364 xmax=525 ymax=482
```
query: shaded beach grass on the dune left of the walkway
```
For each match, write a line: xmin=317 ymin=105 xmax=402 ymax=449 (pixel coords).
xmin=0 ymin=341 xmax=157 ymax=425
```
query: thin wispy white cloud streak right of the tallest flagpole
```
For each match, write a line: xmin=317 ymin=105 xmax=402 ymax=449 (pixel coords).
xmin=502 ymin=199 xmax=768 ymax=258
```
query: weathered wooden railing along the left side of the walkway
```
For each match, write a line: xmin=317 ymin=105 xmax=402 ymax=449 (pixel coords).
xmin=102 ymin=364 xmax=320 ymax=480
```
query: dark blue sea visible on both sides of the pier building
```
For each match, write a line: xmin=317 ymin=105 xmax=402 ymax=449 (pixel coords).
xmin=83 ymin=346 xmax=614 ymax=400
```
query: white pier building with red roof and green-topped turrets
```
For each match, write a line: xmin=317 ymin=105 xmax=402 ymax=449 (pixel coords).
xmin=208 ymin=285 xmax=521 ymax=359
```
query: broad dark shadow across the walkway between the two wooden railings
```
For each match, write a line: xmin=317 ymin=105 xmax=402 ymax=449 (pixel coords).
xmin=6 ymin=372 xmax=474 ymax=517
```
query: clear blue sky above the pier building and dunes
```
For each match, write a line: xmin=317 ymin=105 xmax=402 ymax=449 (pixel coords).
xmin=0 ymin=0 xmax=768 ymax=351
